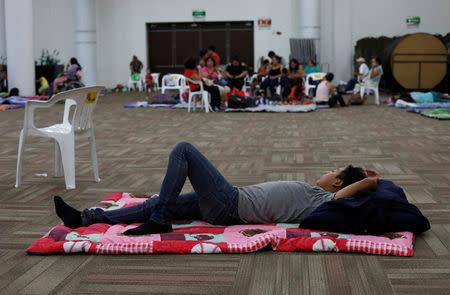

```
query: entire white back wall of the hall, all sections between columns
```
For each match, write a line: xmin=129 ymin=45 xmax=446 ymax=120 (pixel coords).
xmin=29 ymin=0 xmax=450 ymax=86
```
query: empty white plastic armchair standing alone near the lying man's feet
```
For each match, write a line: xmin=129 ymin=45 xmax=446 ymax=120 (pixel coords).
xmin=15 ymin=86 xmax=105 ymax=189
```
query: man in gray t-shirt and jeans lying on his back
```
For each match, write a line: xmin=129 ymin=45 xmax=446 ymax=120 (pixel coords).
xmin=54 ymin=142 xmax=378 ymax=235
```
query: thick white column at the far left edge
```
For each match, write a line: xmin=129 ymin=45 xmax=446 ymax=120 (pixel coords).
xmin=5 ymin=0 xmax=36 ymax=96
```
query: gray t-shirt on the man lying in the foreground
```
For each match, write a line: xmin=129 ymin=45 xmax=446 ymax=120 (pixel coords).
xmin=238 ymin=181 xmax=335 ymax=223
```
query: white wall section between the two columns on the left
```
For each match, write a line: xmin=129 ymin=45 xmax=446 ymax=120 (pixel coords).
xmin=33 ymin=0 xmax=75 ymax=64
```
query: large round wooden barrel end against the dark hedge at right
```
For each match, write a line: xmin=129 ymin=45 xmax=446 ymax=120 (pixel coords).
xmin=383 ymin=33 xmax=448 ymax=89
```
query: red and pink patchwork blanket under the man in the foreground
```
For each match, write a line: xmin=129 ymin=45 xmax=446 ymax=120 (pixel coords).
xmin=27 ymin=193 xmax=414 ymax=256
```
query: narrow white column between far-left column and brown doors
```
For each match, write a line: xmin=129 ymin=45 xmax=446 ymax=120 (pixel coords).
xmin=75 ymin=0 xmax=97 ymax=85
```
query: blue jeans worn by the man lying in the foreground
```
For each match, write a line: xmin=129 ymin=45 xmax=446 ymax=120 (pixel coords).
xmin=81 ymin=142 xmax=243 ymax=226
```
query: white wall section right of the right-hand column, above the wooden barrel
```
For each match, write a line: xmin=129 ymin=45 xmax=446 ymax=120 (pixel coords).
xmin=321 ymin=0 xmax=450 ymax=80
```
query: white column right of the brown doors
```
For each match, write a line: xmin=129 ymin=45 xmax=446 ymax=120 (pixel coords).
xmin=299 ymin=0 xmax=320 ymax=62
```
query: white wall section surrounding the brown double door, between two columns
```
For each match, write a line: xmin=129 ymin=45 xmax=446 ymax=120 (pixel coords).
xmin=97 ymin=0 xmax=296 ymax=85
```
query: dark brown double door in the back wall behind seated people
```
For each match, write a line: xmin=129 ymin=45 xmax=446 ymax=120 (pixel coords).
xmin=147 ymin=21 xmax=253 ymax=76
